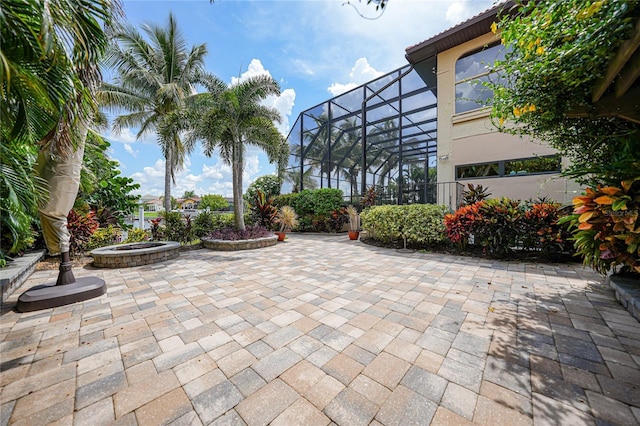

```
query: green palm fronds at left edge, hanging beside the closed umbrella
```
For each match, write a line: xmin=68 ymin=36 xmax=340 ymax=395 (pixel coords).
xmin=0 ymin=0 xmax=119 ymax=258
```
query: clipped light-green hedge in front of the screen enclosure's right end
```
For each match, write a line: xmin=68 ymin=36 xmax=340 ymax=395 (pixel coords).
xmin=360 ymin=204 xmax=447 ymax=245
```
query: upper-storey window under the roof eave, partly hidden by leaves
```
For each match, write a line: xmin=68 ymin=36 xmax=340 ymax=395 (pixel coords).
xmin=456 ymin=44 xmax=505 ymax=113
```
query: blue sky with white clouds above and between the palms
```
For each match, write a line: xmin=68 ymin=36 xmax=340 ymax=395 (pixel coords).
xmin=105 ymin=0 xmax=493 ymax=197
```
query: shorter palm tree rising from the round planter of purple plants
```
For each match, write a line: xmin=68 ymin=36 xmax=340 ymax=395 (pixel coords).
xmin=188 ymin=75 xmax=289 ymax=230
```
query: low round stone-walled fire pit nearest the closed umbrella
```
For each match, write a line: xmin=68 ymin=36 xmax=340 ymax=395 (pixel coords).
xmin=91 ymin=241 xmax=180 ymax=268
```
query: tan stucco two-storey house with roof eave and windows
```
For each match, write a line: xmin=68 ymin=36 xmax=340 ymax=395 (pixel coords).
xmin=406 ymin=4 xmax=579 ymax=204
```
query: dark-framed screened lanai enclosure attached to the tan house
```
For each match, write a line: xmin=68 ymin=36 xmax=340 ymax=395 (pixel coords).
xmin=283 ymin=57 xmax=460 ymax=204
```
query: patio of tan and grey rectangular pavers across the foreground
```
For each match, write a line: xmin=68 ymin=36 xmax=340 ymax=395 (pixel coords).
xmin=0 ymin=235 xmax=640 ymax=426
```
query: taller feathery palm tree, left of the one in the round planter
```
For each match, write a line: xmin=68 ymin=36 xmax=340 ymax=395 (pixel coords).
xmin=98 ymin=14 xmax=212 ymax=210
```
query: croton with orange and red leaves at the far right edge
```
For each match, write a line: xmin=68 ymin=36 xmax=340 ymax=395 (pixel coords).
xmin=567 ymin=176 xmax=640 ymax=273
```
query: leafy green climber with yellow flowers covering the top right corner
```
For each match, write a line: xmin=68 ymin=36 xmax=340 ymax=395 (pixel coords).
xmin=491 ymin=0 xmax=640 ymax=187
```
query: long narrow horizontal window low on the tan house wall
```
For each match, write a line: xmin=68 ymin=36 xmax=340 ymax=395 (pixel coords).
xmin=456 ymin=155 xmax=561 ymax=179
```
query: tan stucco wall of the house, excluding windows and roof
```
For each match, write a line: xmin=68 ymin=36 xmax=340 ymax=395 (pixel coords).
xmin=437 ymin=33 xmax=580 ymax=207
